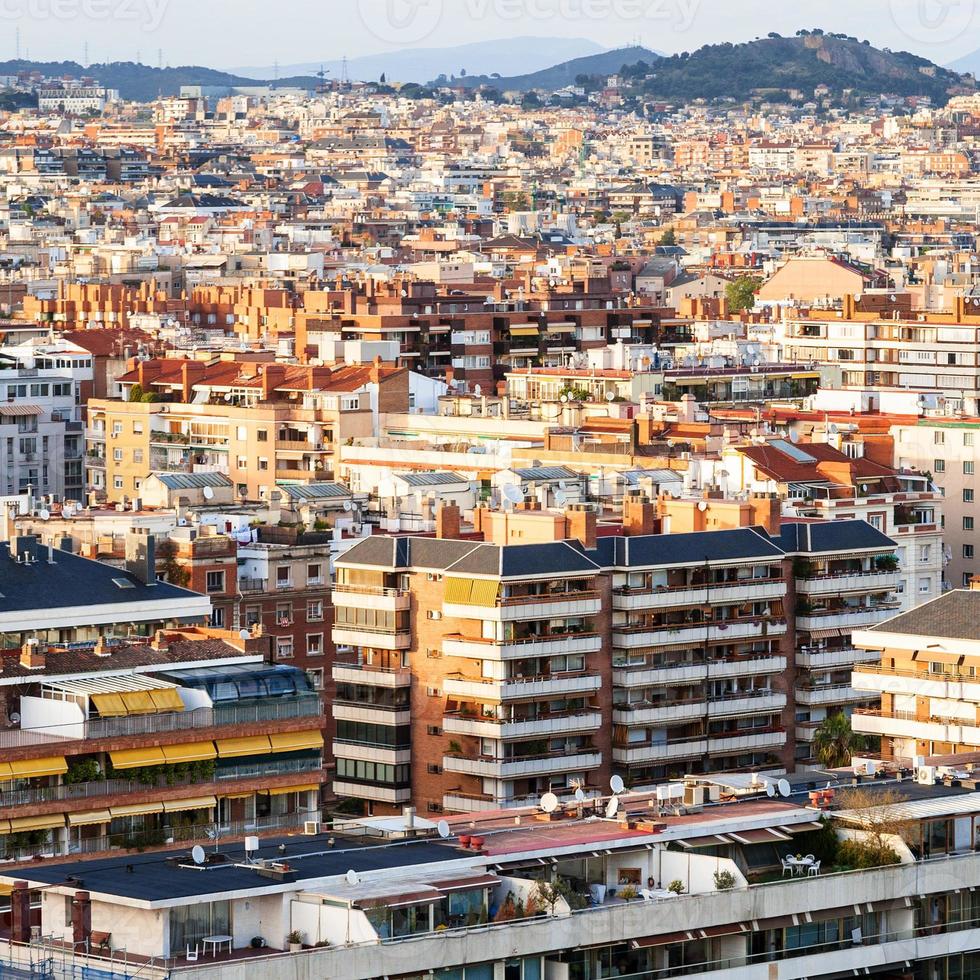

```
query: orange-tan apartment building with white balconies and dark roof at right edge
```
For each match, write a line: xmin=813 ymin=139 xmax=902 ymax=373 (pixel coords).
xmin=851 ymin=581 xmax=980 ymax=771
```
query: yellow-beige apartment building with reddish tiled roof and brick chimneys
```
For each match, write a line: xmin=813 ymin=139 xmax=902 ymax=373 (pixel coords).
xmin=86 ymin=359 xmax=409 ymax=502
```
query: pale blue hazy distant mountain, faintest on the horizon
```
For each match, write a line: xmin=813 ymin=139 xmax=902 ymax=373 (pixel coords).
xmin=234 ymin=37 xmax=605 ymax=84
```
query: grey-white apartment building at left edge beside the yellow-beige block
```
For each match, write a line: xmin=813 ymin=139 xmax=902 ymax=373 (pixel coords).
xmin=0 ymin=343 xmax=93 ymax=500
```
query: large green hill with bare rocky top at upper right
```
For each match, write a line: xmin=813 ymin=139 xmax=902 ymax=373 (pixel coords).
xmin=640 ymin=34 xmax=972 ymax=104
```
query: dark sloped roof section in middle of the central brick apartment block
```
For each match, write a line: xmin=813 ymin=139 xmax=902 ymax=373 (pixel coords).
xmin=616 ymin=527 xmax=783 ymax=567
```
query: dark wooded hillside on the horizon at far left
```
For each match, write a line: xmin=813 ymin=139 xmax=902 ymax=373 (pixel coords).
xmin=0 ymin=60 xmax=318 ymax=102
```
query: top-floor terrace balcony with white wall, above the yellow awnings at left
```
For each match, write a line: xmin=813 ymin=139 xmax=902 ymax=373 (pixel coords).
xmin=0 ymin=696 xmax=323 ymax=749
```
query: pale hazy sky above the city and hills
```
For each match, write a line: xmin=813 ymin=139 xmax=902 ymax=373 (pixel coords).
xmin=9 ymin=0 xmax=980 ymax=67
